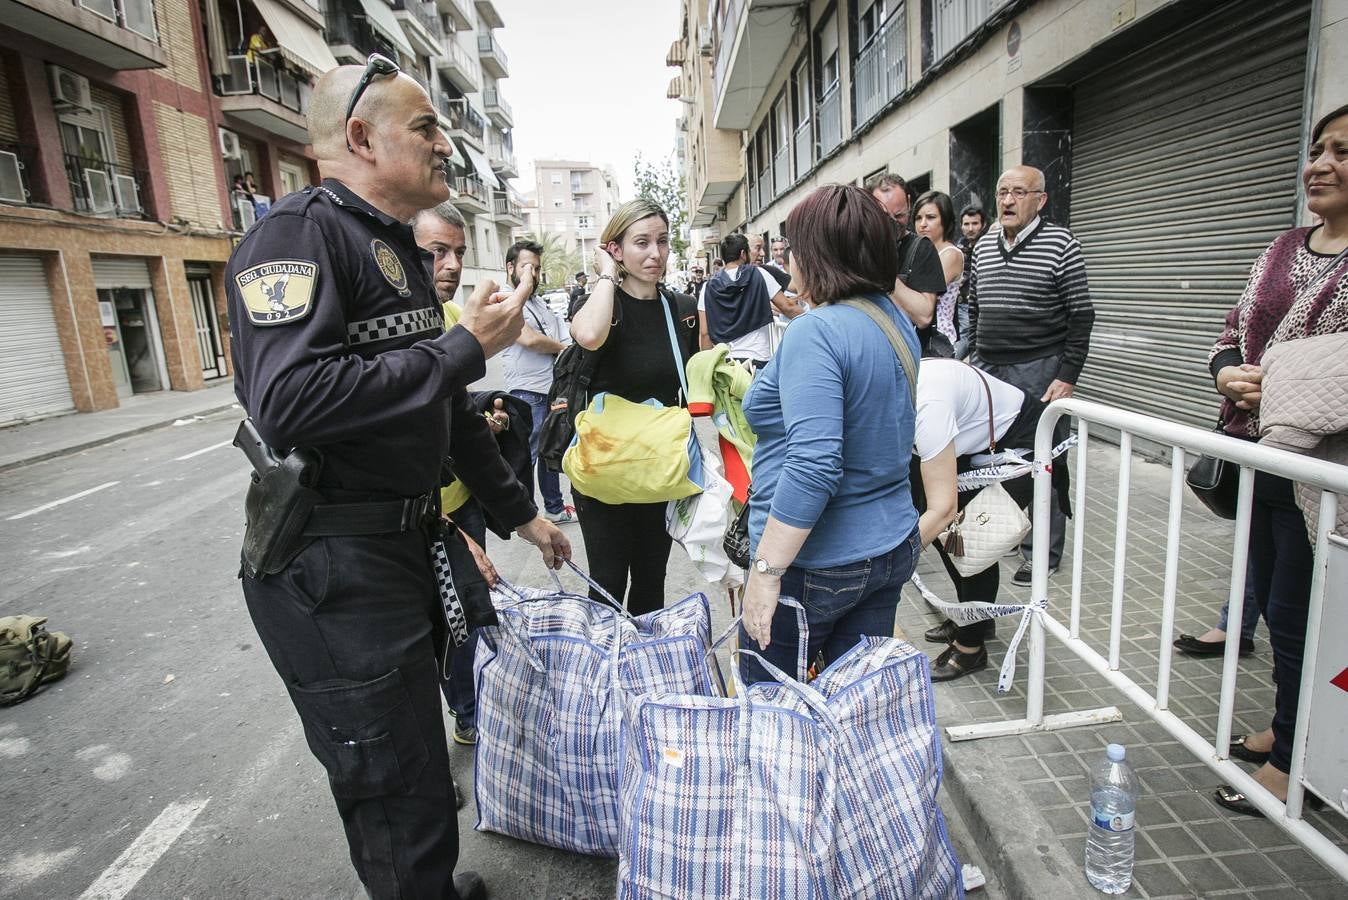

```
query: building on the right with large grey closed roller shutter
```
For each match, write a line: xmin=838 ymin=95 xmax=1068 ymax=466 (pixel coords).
xmin=671 ymin=0 xmax=1348 ymax=427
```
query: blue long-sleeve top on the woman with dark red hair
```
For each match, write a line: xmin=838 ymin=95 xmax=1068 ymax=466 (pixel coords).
xmin=744 ymin=294 xmax=919 ymax=569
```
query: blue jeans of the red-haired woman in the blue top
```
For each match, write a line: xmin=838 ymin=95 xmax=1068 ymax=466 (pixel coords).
xmin=739 ymin=528 xmax=922 ymax=684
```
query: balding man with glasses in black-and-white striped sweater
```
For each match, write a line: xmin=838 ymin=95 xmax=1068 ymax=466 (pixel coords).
xmin=969 ymin=166 xmax=1095 ymax=585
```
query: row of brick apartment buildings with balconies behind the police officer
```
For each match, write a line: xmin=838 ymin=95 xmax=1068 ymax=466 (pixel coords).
xmin=0 ymin=0 xmax=523 ymax=426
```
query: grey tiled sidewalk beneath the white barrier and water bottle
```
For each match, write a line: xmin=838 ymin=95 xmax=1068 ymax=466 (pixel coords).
xmin=898 ymin=439 xmax=1348 ymax=900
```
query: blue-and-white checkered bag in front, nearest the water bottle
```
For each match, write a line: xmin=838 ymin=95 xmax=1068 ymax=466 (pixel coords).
xmin=617 ymin=637 xmax=964 ymax=900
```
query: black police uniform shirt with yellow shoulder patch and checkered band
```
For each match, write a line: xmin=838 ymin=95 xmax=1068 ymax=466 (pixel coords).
xmin=225 ymin=179 xmax=537 ymax=528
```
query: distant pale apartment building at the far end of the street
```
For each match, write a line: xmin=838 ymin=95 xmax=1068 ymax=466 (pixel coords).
xmin=526 ymin=159 xmax=621 ymax=260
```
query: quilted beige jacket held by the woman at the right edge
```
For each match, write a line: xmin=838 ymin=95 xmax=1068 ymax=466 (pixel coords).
xmin=1259 ymin=331 xmax=1348 ymax=540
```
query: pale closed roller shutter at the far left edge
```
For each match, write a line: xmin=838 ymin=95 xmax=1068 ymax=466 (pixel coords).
xmin=0 ymin=256 xmax=74 ymax=424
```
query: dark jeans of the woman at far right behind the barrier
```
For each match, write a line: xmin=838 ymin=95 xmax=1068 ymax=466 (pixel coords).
xmin=1250 ymin=472 xmax=1314 ymax=772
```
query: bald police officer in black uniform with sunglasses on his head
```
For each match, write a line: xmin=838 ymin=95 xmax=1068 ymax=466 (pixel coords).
xmin=225 ymin=57 xmax=570 ymax=900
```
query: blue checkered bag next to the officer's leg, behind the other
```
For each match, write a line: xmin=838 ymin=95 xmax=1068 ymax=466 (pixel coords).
xmin=473 ymin=573 xmax=720 ymax=857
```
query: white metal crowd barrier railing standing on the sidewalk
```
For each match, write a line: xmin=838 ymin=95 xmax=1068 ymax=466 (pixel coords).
xmin=946 ymin=399 xmax=1348 ymax=880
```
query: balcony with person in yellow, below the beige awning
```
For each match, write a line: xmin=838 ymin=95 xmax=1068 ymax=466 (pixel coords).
xmin=216 ymin=49 xmax=311 ymax=144
